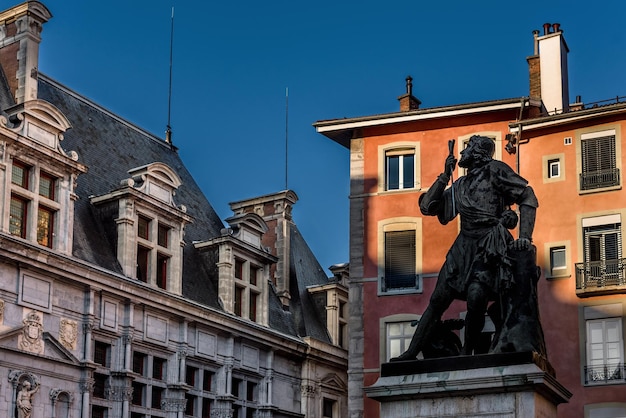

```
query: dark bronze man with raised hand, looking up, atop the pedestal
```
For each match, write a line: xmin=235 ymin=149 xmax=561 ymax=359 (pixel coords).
xmin=392 ymin=135 xmax=538 ymax=361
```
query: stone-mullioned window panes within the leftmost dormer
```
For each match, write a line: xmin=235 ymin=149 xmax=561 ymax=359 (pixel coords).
xmin=9 ymin=159 xmax=60 ymax=248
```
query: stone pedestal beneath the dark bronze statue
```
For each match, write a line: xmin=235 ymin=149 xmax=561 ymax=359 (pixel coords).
xmin=365 ymin=352 xmax=572 ymax=418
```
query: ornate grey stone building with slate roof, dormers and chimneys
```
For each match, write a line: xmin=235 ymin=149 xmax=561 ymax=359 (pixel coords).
xmin=0 ymin=1 xmax=347 ymax=418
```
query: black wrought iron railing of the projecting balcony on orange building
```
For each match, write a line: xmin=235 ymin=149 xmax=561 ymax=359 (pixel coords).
xmin=576 ymin=258 xmax=626 ymax=290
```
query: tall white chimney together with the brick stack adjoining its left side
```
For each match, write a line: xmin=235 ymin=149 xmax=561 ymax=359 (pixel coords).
xmin=526 ymin=23 xmax=569 ymax=115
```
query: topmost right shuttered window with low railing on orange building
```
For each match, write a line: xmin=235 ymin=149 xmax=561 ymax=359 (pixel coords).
xmin=580 ymin=129 xmax=620 ymax=191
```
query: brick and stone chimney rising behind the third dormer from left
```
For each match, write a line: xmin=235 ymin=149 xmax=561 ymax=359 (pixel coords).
xmin=230 ymin=190 xmax=298 ymax=310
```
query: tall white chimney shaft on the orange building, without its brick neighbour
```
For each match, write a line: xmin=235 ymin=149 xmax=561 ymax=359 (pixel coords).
xmin=537 ymin=23 xmax=569 ymax=115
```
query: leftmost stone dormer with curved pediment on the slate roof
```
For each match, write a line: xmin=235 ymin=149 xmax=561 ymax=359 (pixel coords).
xmin=0 ymin=100 xmax=87 ymax=255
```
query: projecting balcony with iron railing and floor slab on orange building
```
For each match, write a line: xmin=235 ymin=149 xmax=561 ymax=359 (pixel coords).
xmin=576 ymin=258 xmax=626 ymax=296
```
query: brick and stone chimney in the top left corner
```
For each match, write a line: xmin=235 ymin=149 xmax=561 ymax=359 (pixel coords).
xmin=0 ymin=1 xmax=52 ymax=104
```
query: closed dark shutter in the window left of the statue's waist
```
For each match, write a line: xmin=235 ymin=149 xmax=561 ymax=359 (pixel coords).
xmin=385 ymin=231 xmax=416 ymax=289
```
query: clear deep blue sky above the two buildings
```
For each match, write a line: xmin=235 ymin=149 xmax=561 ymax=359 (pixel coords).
xmin=37 ymin=0 xmax=626 ymax=274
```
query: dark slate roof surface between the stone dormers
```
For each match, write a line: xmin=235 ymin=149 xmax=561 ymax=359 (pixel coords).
xmin=25 ymin=71 xmax=330 ymax=343
